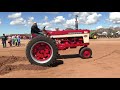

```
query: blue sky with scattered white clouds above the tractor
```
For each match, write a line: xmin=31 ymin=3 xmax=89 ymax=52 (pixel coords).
xmin=0 ymin=12 xmax=120 ymax=36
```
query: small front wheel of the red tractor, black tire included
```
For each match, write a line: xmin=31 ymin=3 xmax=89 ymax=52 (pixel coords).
xmin=79 ymin=47 xmax=92 ymax=59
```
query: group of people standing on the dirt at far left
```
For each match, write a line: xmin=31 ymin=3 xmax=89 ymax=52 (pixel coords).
xmin=2 ymin=34 xmax=21 ymax=48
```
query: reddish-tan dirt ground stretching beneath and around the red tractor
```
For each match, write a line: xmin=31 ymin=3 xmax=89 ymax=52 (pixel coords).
xmin=0 ymin=39 xmax=120 ymax=78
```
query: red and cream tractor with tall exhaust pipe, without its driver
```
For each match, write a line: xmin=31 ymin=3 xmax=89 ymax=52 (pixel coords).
xmin=26 ymin=17 xmax=92 ymax=66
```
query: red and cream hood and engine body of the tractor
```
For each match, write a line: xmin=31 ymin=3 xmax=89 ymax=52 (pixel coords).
xmin=47 ymin=30 xmax=90 ymax=50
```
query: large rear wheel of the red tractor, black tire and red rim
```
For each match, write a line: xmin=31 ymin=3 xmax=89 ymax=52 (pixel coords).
xmin=26 ymin=36 xmax=58 ymax=66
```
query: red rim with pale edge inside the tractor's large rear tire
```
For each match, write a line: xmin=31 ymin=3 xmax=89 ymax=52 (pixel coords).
xmin=31 ymin=41 xmax=53 ymax=63
